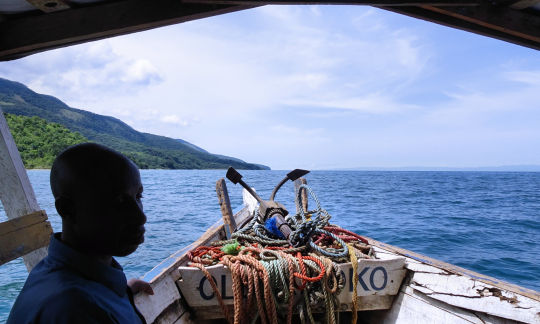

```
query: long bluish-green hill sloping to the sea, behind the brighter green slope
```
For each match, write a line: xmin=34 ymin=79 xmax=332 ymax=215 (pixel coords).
xmin=0 ymin=78 xmax=269 ymax=170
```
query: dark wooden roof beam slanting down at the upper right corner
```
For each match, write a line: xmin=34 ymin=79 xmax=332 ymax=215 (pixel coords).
xmin=379 ymin=6 xmax=540 ymax=50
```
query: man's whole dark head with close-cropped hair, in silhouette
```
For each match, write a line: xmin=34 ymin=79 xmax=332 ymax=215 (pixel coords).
xmin=51 ymin=143 xmax=146 ymax=256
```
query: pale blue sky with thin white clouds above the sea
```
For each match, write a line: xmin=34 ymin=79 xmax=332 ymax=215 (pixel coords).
xmin=0 ymin=6 xmax=540 ymax=170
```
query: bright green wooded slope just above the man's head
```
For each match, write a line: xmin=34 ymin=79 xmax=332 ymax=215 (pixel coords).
xmin=4 ymin=114 xmax=88 ymax=169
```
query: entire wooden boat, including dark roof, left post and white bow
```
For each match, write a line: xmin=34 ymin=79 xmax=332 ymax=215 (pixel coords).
xmin=0 ymin=0 xmax=540 ymax=323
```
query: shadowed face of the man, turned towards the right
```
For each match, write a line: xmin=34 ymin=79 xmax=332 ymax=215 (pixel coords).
xmin=75 ymin=163 xmax=146 ymax=256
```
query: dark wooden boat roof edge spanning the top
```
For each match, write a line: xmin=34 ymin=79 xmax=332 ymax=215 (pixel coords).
xmin=0 ymin=0 xmax=540 ymax=61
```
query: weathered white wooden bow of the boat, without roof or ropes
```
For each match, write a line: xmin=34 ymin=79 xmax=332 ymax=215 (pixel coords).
xmin=130 ymin=168 xmax=540 ymax=323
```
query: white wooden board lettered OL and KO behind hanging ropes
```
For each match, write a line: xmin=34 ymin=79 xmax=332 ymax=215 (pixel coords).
xmin=178 ymin=257 xmax=406 ymax=311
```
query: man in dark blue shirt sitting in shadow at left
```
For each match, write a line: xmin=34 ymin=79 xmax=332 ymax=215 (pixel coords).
xmin=7 ymin=143 xmax=153 ymax=324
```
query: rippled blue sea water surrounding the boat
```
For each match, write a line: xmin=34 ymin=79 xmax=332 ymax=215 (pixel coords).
xmin=0 ymin=170 xmax=540 ymax=323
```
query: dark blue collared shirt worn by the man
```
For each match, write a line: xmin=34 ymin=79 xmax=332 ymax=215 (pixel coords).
xmin=6 ymin=233 xmax=145 ymax=324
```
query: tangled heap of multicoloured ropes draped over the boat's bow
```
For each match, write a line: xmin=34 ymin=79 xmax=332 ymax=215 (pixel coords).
xmin=184 ymin=185 xmax=372 ymax=324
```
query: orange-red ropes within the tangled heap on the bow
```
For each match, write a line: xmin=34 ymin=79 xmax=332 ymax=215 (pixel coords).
xmin=188 ymin=226 xmax=368 ymax=324
